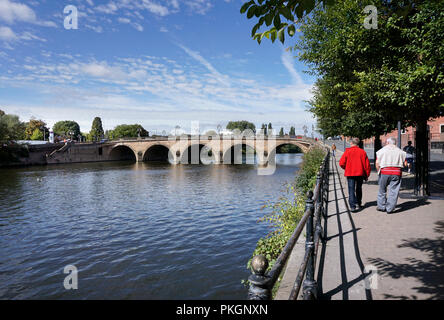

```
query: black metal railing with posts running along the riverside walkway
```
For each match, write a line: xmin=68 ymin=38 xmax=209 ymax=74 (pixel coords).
xmin=248 ymin=150 xmax=330 ymax=300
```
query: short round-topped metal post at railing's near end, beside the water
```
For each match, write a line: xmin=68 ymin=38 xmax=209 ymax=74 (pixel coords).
xmin=248 ymin=255 xmax=271 ymax=300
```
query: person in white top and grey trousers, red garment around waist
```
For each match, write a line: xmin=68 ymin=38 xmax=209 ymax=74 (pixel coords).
xmin=376 ymin=138 xmax=407 ymax=213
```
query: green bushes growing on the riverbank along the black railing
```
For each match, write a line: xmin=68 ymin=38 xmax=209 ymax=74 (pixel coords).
xmin=247 ymin=148 xmax=325 ymax=269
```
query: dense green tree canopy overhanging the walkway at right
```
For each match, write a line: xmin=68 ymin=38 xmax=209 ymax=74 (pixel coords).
xmin=295 ymin=0 xmax=444 ymax=138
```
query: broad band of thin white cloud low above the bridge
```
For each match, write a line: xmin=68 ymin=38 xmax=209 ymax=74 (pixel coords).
xmin=0 ymin=45 xmax=312 ymax=128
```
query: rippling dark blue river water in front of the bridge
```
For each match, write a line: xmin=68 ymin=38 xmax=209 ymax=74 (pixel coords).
xmin=0 ymin=154 xmax=300 ymax=299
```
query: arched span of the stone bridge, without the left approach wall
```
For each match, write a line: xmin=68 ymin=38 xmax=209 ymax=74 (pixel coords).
xmin=104 ymin=136 xmax=315 ymax=164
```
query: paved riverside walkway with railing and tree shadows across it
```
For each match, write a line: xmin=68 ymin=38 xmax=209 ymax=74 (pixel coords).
xmin=275 ymin=150 xmax=444 ymax=300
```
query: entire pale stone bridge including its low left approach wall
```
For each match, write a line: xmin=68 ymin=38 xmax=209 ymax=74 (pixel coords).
xmin=46 ymin=136 xmax=316 ymax=165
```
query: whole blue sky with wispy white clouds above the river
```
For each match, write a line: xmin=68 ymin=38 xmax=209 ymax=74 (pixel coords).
xmin=0 ymin=0 xmax=315 ymax=133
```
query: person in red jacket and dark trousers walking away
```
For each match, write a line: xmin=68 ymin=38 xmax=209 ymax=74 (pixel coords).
xmin=339 ymin=138 xmax=371 ymax=212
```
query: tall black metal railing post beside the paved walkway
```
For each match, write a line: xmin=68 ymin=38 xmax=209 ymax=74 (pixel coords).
xmin=303 ymin=191 xmax=317 ymax=300
